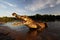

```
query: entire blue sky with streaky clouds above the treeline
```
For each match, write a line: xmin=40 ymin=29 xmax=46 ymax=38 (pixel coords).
xmin=0 ymin=0 xmax=60 ymax=17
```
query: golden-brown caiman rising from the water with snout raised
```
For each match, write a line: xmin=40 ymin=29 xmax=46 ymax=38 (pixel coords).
xmin=12 ymin=13 xmax=47 ymax=30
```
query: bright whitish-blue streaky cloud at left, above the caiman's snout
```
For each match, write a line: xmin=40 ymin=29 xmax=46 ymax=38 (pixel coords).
xmin=0 ymin=1 xmax=26 ymax=16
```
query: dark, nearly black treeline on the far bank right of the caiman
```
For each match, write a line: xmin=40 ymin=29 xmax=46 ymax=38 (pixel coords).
xmin=30 ymin=14 xmax=60 ymax=21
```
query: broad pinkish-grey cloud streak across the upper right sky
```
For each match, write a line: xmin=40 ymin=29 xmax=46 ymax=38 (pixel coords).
xmin=25 ymin=0 xmax=60 ymax=11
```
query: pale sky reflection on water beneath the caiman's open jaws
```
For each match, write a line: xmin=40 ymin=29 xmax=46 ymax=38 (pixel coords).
xmin=3 ymin=22 xmax=28 ymax=31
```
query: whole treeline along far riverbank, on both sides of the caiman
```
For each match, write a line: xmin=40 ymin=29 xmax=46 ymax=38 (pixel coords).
xmin=0 ymin=14 xmax=60 ymax=22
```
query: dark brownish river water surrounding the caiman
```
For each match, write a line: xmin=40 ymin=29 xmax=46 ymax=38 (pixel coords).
xmin=0 ymin=21 xmax=60 ymax=40
